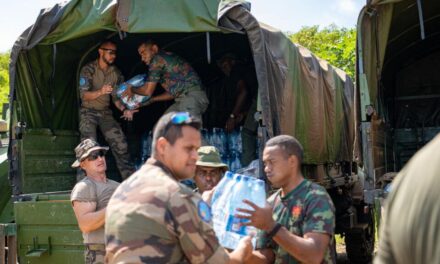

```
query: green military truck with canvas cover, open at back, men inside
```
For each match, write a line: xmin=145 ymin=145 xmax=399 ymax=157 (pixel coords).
xmin=0 ymin=0 xmax=392 ymax=263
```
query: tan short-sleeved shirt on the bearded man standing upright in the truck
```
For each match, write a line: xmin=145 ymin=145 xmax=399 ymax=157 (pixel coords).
xmin=79 ymin=60 xmax=124 ymax=110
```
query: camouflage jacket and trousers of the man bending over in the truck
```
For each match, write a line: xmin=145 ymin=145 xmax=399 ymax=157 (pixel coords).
xmin=147 ymin=51 xmax=209 ymax=120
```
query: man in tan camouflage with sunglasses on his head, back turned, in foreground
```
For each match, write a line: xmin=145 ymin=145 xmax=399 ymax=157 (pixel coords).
xmin=105 ymin=112 xmax=252 ymax=263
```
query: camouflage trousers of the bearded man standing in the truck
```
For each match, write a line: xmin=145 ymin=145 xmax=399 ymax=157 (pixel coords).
xmin=79 ymin=108 xmax=134 ymax=179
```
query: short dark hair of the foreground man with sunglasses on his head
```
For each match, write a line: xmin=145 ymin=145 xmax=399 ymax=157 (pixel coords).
xmin=151 ymin=112 xmax=202 ymax=156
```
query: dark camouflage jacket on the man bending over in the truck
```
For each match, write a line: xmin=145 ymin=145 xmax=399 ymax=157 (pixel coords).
xmin=147 ymin=51 xmax=202 ymax=97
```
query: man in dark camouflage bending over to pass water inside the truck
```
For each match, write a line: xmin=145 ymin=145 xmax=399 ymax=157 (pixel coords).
xmin=124 ymin=40 xmax=209 ymax=119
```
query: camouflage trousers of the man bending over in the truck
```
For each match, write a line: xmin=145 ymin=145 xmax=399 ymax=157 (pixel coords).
xmin=165 ymin=90 xmax=209 ymax=120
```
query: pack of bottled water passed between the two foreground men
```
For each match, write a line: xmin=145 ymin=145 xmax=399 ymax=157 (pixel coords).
xmin=211 ymin=171 xmax=266 ymax=249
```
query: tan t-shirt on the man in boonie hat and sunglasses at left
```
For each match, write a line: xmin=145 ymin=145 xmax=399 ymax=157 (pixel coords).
xmin=70 ymin=177 xmax=119 ymax=244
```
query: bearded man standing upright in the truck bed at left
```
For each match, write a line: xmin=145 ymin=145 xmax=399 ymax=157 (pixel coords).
xmin=79 ymin=41 xmax=138 ymax=179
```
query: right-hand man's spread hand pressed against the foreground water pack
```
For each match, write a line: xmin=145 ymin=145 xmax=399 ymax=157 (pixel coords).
xmin=236 ymin=200 xmax=275 ymax=232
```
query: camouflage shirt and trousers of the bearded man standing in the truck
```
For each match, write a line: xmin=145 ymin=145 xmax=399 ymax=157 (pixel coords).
xmin=79 ymin=60 xmax=134 ymax=179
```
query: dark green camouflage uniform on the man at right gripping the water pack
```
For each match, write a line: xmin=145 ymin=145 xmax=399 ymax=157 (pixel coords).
xmin=257 ymin=180 xmax=335 ymax=264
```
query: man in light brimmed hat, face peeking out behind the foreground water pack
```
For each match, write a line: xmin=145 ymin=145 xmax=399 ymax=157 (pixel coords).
xmin=194 ymin=146 xmax=228 ymax=194
